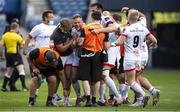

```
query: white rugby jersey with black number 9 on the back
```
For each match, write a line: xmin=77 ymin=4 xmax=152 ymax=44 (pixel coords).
xmin=122 ymin=22 xmax=150 ymax=60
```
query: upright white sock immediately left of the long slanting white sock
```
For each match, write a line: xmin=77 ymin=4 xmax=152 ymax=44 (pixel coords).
xmin=99 ymin=83 xmax=106 ymax=103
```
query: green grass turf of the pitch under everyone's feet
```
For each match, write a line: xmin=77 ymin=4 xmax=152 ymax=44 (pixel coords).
xmin=0 ymin=70 xmax=180 ymax=111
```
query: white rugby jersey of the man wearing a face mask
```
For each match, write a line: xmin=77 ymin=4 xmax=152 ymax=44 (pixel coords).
xmin=29 ymin=23 xmax=56 ymax=48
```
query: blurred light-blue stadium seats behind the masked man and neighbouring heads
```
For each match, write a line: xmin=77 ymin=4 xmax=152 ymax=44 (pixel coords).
xmin=27 ymin=0 xmax=89 ymax=29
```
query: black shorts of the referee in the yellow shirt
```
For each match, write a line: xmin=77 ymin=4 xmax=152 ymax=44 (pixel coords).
xmin=6 ymin=53 xmax=23 ymax=67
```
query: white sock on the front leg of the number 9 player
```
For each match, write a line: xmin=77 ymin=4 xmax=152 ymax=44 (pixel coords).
xmin=131 ymin=82 xmax=146 ymax=96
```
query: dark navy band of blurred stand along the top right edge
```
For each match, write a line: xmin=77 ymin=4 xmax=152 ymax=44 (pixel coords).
xmin=98 ymin=0 xmax=180 ymax=12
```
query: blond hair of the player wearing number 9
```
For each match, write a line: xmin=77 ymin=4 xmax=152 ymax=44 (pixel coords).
xmin=128 ymin=9 xmax=139 ymax=21
